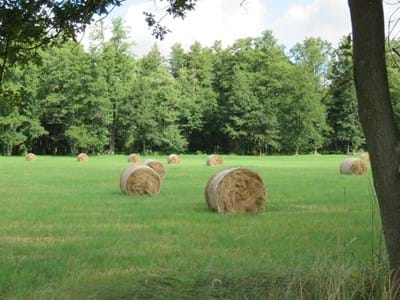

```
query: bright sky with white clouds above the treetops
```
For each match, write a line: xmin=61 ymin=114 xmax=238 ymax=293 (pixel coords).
xmin=84 ymin=0 xmax=394 ymax=57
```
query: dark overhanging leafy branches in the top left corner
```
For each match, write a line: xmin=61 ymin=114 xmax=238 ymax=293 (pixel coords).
xmin=0 ymin=0 xmax=123 ymax=86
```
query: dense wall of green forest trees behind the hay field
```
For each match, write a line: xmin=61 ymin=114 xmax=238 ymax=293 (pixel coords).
xmin=0 ymin=19 xmax=400 ymax=155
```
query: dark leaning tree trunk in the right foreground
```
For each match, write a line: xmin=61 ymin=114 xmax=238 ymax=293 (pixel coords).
xmin=348 ymin=0 xmax=400 ymax=288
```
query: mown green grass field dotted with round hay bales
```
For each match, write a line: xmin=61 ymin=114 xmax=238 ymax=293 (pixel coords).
xmin=0 ymin=155 xmax=385 ymax=299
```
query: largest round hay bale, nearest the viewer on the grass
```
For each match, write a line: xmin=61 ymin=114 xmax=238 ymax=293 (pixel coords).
xmin=205 ymin=168 xmax=267 ymax=213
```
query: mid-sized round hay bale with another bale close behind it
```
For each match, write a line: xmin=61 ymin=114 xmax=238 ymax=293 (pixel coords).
xmin=120 ymin=164 xmax=161 ymax=195
